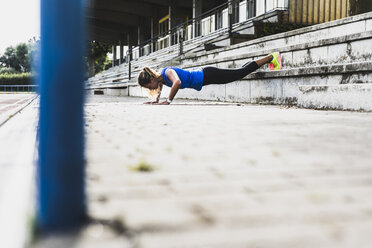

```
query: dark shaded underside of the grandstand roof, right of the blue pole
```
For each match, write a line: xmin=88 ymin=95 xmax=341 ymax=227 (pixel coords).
xmin=86 ymin=0 xmax=227 ymax=45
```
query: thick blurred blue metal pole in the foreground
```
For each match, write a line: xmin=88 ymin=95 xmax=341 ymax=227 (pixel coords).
xmin=37 ymin=0 xmax=86 ymax=232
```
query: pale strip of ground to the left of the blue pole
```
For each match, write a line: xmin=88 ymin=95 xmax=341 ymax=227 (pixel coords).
xmin=0 ymin=94 xmax=39 ymax=248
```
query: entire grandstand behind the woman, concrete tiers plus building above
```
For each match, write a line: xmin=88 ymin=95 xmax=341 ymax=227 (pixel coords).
xmin=86 ymin=0 xmax=372 ymax=110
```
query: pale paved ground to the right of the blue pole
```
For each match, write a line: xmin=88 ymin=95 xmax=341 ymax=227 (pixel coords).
xmin=35 ymin=96 xmax=372 ymax=248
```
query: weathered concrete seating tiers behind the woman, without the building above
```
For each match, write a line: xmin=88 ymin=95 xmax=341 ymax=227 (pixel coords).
xmin=88 ymin=13 xmax=372 ymax=110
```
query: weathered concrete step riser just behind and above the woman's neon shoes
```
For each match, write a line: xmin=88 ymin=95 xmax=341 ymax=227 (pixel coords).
xmin=181 ymin=30 xmax=372 ymax=68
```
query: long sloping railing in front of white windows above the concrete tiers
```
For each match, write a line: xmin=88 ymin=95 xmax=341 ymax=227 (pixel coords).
xmin=124 ymin=0 xmax=288 ymax=62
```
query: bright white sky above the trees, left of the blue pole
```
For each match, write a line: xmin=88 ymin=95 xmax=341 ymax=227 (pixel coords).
xmin=0 ymin=0 xmax=40 ymax=55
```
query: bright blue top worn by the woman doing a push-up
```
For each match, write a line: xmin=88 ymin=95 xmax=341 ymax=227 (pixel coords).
xmin=161 ymin=67 xmax=204 ymax=91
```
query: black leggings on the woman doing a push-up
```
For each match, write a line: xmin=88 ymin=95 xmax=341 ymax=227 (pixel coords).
xmin=203 ymin=61 xmax=259 ymax=85
